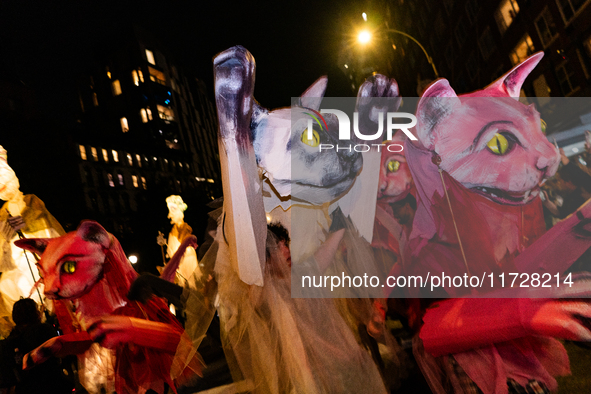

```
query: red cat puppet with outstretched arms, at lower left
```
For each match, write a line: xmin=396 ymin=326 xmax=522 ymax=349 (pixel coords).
xmin=16 ymin=221 xmax=201 ymax=393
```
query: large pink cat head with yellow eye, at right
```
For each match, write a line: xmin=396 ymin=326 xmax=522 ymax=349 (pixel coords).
xmin=417 ymin=53 xmax=560 ymax=205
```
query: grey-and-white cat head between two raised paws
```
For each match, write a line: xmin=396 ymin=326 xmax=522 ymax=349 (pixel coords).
xmin=251 ymin=77 xmax=363 ymax=204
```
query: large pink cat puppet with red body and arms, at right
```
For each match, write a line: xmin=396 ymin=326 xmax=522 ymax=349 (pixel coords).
xmin=403 ymin=53 xmax=591 ymax=393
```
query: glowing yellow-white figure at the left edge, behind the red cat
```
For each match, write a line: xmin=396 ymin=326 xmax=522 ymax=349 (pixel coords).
xmin=0 ymin=146 xmax=64 ymax=336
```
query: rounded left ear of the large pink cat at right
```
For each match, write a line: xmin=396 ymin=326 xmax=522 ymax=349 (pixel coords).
xmin=416 ymin=79 xmax=461 ymax=150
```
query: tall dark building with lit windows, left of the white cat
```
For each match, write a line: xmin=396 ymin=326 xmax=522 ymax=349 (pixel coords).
xmin=71 ymin=27 xmax=221 ymax=270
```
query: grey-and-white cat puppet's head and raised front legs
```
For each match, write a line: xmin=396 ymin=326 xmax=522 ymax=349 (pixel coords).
xmin=214 ymin=46 xmax=398 ymax=285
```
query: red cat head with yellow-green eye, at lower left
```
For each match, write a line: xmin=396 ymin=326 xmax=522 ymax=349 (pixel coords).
xmin=15 ymin=221 xmax=111 ymax=300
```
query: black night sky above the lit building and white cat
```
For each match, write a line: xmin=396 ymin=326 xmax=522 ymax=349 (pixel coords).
xmin=0 ymin=0 xmax=362 ymax=108
